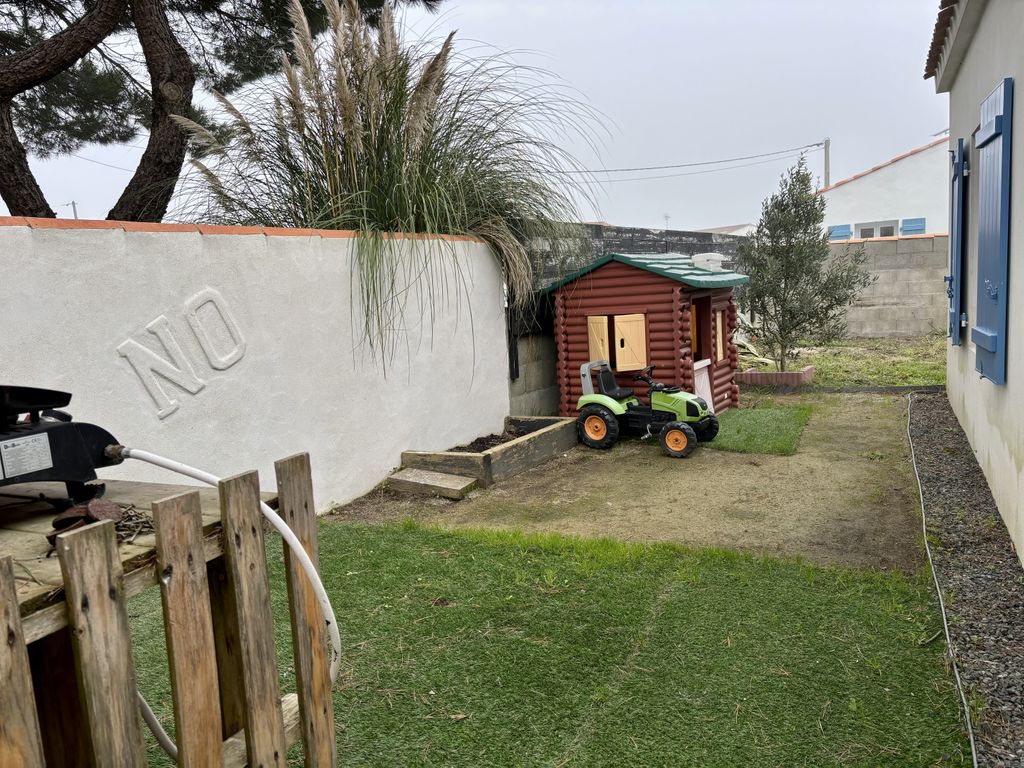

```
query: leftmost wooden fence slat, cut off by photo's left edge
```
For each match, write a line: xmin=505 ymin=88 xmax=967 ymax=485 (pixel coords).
xmin=0 ymin=557 xmax=44 ymax=768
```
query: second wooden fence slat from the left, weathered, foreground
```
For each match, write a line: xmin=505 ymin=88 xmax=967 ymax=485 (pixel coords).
xmin=56 ymin=520 xmax=146 ymax=768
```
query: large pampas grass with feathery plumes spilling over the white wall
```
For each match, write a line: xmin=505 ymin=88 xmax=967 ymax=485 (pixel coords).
xmin=178 ymin=0 xmax=595 ymax=357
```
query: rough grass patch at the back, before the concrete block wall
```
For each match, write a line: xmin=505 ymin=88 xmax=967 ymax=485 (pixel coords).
xmin=741 ymin=335 xmax=949 ymax=387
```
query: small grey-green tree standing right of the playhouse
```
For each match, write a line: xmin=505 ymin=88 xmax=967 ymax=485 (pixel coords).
xmin=736 ymin=157 xmax=874 ymax=371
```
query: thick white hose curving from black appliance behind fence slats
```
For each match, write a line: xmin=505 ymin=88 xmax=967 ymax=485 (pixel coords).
xmin=118 ymin=446 xmax=341 ymax=759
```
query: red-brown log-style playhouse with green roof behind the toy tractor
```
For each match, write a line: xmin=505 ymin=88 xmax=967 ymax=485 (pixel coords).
xmin=544 ymin=253 xmax=748 ymax=416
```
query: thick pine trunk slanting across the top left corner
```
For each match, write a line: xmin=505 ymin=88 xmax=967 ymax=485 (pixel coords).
xmin=0 ymin=0 xmax=128 ymax=101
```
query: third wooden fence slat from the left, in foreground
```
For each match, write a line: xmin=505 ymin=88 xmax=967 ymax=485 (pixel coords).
xmin=153 ymin=492 xmax=223 ymax=768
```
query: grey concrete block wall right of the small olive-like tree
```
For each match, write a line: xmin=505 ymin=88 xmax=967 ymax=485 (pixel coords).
xmin=831 ymin=234 xmax=949 ymax=337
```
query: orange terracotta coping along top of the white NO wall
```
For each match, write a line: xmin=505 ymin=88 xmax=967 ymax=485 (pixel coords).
xmin=0 ymin=216 xmax=483 ymax=243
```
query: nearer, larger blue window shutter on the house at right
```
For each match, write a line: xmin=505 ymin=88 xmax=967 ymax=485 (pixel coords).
xmin=971 ymin=78 xmax=1014 ymax=384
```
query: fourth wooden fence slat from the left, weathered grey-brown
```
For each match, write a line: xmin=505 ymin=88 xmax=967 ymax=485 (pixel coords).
xmin=220 ymin=472 xmax=287 ymax=768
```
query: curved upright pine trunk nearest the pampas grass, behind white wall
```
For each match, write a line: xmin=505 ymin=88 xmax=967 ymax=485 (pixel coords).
xmin=106 ymin=0 xmax=196 ymax=221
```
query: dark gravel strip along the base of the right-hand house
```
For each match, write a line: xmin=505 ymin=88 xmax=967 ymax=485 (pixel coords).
xmin=910 ymin=394 xmax=1024 ymax=768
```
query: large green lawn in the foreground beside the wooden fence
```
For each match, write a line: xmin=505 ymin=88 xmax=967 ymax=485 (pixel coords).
xmin=130 ymin=523 xmax=970 ymax=766
